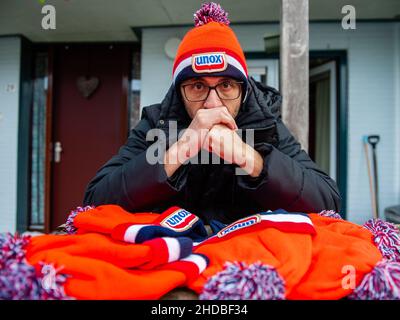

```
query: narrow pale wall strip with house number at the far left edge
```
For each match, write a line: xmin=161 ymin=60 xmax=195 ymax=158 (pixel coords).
xmin=0 ymin=37 xmax=21 ymax=232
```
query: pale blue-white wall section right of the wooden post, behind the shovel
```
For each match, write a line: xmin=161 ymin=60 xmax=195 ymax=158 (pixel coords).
xmin=310 ymin=23 xmax=400 ymax=223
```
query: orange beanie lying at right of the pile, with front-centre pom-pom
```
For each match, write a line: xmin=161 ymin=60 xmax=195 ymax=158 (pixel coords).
xmin=189 ymin=210 xmax=384 ymax=300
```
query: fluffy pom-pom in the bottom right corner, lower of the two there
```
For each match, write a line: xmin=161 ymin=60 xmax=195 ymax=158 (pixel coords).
xmin=348 ymin=260 xmax=400 ymax=300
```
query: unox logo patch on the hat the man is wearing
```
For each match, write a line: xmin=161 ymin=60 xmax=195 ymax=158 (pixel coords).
xmin=192 ymin=52 xmax=228 ymax=73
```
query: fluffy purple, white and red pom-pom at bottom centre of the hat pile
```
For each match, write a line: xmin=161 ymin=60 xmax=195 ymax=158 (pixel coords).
xmin=199 ymin=262 xmax=285 ymax=300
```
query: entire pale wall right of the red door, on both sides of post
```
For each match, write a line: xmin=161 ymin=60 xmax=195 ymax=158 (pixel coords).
xmin=141 ymin=23 xmax=400 ymax=223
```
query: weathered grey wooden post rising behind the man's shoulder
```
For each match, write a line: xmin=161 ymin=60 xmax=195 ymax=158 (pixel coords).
xmin=280 ymin=0 xmax=309 ymax=151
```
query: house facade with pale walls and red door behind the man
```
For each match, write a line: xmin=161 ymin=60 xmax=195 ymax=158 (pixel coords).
xmin=0 ymin=2 xmax=400 ymax=232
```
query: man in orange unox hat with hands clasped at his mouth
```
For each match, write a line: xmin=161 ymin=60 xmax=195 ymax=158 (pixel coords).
xmin=84 ymin=3 xmax=341 ymax=223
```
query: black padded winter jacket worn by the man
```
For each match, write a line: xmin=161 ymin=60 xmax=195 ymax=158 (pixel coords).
xmin=84 ymin=79 xmax=341 ymax=223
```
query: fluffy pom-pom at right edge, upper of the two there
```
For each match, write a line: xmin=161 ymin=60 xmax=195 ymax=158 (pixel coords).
xmin=363 ymin=219 xmax=400 ymax=262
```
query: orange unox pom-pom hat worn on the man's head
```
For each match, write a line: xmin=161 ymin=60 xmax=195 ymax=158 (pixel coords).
xmin=173 ymin=2 xmax=248 ymax=90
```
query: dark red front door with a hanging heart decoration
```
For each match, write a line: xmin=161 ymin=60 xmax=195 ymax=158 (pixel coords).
xmin=50 ymin=44 xmax=131 ymax=230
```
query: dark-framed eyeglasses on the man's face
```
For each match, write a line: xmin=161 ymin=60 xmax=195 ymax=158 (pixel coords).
xmin=182 ymin=80 xmax=243 ymax=102
